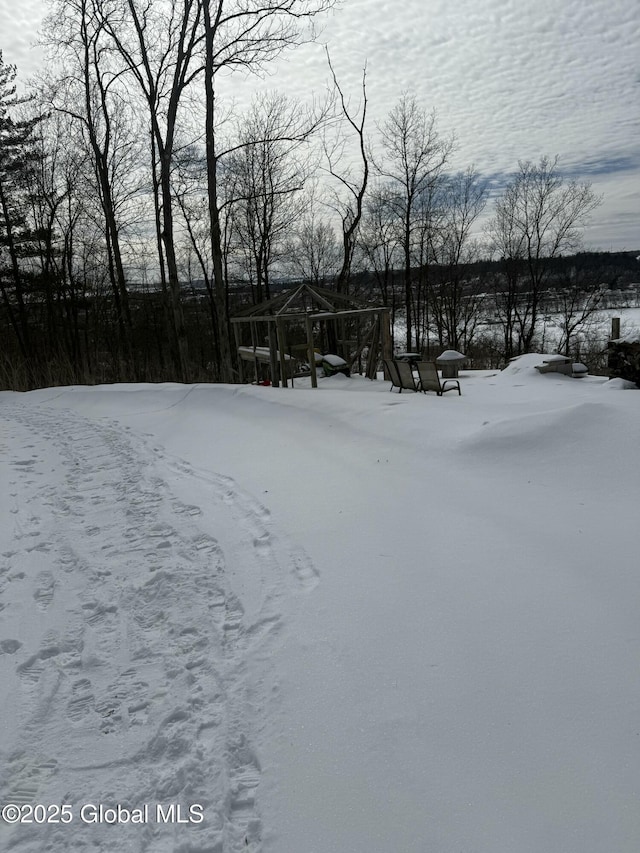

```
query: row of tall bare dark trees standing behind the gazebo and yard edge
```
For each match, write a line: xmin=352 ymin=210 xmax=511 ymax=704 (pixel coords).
xmin=0 ymin=0 xmax=616 ymax=388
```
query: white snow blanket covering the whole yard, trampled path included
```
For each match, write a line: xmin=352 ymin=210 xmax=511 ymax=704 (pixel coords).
xmin=0 ymin=357 xmax=640 ymax=853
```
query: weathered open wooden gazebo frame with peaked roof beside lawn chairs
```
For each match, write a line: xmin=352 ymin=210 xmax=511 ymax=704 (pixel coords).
xmin=231 ymin=284 xmax=391 ymax=388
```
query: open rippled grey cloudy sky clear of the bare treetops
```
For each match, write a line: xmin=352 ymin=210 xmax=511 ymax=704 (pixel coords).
xmin=0 ymin=0 xmax=640 ymax=251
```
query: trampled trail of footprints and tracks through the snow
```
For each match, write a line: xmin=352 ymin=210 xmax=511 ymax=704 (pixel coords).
xmin=0 ymin=404 xmax=317 ymax=853
